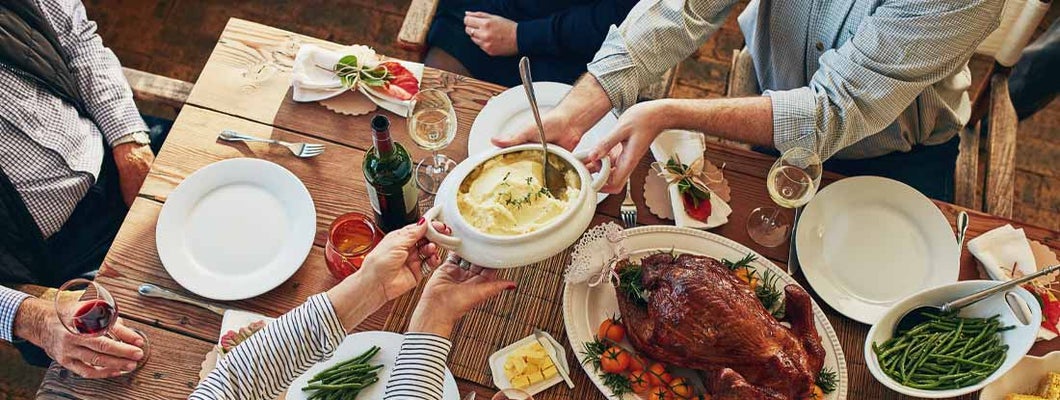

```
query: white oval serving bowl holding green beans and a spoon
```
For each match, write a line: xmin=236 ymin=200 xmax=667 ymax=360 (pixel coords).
xmin=864 ymin=280 xmax=1042 ymax=399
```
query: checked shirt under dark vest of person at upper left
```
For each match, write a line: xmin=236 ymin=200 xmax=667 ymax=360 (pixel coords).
xmin=0 ymin=0 xmax=147 ymax=238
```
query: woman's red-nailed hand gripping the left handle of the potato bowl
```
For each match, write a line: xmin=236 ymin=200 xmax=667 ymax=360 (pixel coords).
xmin=355 ymin=219 xmax=449 ymax=302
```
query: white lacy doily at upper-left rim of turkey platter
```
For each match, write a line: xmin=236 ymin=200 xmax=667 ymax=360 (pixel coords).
xmin=566 ymin=222 xmax=625 ymax=286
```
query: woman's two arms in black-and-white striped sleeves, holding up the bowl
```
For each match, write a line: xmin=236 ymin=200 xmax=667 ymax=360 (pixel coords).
xmin=190 ymin=219 xmax=515 ymax=400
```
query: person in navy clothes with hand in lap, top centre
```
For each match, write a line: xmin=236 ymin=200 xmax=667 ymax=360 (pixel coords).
xmin=424 ymin=0 xmax=636 ymax=86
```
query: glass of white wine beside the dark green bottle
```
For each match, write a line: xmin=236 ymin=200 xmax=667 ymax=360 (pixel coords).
xmin=407 ymin=89 xmax=457 ymax=194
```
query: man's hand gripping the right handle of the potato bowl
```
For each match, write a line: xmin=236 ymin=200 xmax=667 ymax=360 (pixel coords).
xmin=586 ymin=101 xmax=666 ymax=193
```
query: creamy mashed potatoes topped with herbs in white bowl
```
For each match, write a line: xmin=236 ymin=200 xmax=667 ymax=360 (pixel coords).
xmin=457 ymin=151 xmax=581 ymax=236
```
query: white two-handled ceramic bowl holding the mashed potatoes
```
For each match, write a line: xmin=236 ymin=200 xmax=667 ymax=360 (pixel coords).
xmin=423 ymin=143 xmax=611 ymax=268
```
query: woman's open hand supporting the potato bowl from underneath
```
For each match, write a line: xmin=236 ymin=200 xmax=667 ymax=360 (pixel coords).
xmin=408 ymin=255 xmax=515 ymax=337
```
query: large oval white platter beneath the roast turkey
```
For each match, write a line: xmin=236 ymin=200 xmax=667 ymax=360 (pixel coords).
xmin=563 ymin=225 xmax=847 ymax=400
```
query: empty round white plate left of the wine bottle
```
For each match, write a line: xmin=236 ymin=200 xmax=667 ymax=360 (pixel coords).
xmin=155 ymin=158 xmax=317 ymax=300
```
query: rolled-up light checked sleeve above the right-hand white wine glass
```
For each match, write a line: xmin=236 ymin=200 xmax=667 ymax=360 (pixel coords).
xmin=765 ymin=0 xmax=1003 ymax=159
